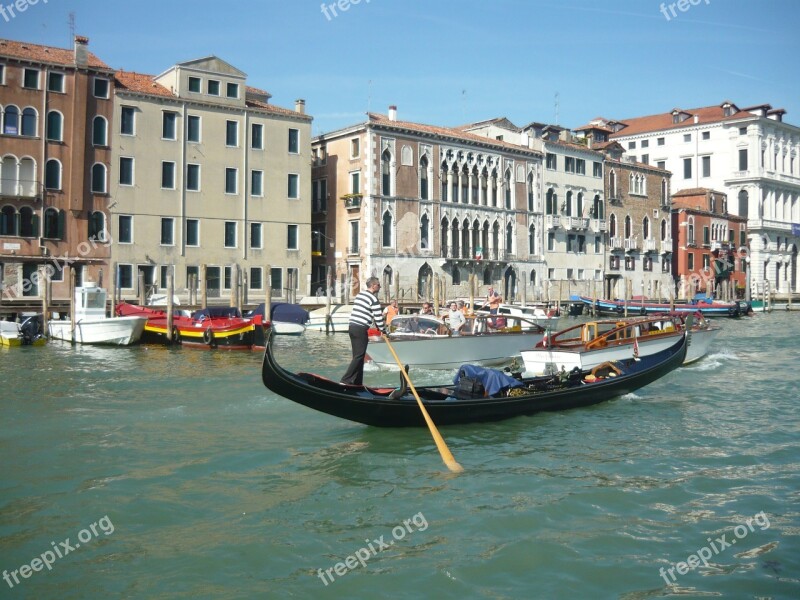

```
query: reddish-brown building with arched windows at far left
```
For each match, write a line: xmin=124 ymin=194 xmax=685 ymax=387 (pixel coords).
xmin=0 ymin=36 xmax=114 ymax=303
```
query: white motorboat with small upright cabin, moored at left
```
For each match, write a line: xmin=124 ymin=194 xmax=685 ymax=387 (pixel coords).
xmin=47 ymin=282 xmax=147 ymax=346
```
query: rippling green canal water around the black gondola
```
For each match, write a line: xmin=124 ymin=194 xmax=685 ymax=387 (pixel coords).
xmin=0 ymin=313 xmax=800 ymax=600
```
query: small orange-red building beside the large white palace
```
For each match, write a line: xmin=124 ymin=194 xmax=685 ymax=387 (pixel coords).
xmin=672 ymin=188 xmax=748 ymax=298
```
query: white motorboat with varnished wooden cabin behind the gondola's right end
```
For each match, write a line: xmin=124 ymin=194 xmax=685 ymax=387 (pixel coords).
xmin=522 ymin=315 xmax=708 ymax=375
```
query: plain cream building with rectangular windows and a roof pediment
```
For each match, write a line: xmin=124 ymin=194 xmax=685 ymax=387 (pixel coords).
xmin=112 ymin=56 xmax=311 ymax=303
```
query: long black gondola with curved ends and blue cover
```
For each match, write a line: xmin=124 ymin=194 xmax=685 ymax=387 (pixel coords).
xmin=261 ymin=329 xmax=688 ymax=427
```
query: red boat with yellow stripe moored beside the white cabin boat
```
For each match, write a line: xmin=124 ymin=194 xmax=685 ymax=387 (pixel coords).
xmin=116 ymin=302 xmax=256 ymax=350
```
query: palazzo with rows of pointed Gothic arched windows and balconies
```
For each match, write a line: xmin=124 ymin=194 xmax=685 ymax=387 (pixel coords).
xmin=312 ymin=107 xmax=542 ymax=302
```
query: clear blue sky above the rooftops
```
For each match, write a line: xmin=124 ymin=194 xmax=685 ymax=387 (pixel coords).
xmin=0 ymin=0 xmax=800 ymax=134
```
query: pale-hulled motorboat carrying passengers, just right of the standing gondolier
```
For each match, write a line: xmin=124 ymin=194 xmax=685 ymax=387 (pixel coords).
xmin=367 ymin=315 xmax=545 ymax=369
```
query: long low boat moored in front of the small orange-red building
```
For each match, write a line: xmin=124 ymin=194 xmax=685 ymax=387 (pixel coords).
xmin=570 ymin=294 xmax=753 ymax=318
